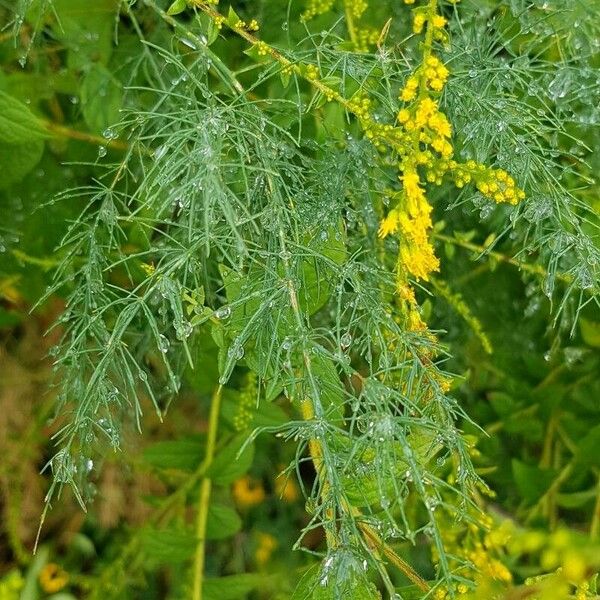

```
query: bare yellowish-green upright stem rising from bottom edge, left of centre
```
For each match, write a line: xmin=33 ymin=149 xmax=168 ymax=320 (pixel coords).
xmin=192 ymin=385 xmax=223 ymax=600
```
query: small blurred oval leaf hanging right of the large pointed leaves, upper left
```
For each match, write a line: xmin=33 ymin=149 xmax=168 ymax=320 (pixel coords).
xmin=80 ymin=64 xmax=123 ymax=133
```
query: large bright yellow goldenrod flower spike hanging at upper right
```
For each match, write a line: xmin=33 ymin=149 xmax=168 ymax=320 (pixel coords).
xmin=378 ymin=0 xmax=525 ymax=290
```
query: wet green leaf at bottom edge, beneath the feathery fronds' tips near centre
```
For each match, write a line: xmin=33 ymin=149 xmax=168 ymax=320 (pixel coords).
xmin=290 ymin=565 xmax=381 ymax=600
